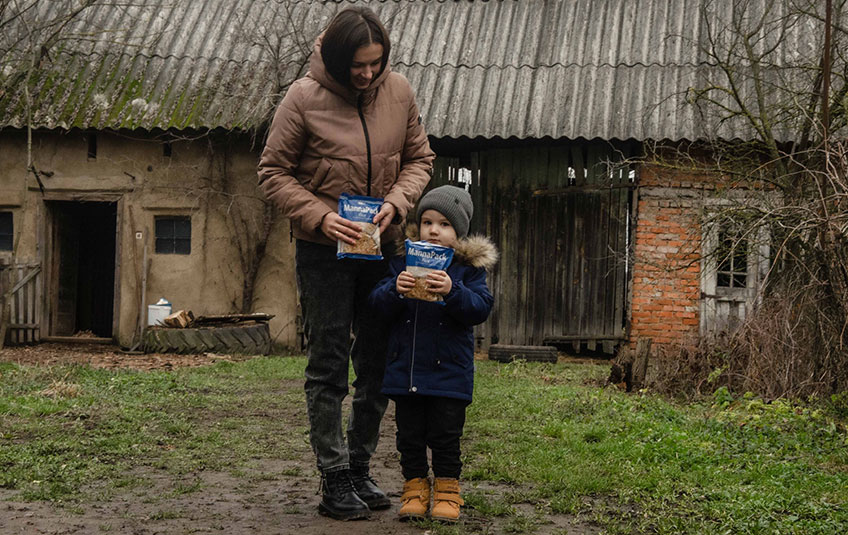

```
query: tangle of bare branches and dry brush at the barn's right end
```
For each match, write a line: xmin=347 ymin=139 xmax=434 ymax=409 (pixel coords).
xmin=654 ymin=0 xmax=848 ymax=397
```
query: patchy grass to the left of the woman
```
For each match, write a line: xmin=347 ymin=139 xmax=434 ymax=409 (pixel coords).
xmin=0 ymin=359 xmax=308 ymax=503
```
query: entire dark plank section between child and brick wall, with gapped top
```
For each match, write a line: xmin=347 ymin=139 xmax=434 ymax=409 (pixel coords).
xmin=431 ymin=141 xmax=635 ymax=351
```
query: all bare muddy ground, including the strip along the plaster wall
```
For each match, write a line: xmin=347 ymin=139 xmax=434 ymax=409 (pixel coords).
xmin=0 ymin=344 xmax=601 ymax=535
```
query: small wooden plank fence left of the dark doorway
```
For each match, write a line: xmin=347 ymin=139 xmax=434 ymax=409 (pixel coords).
xmin=0 ymin=263 xmax=42 ymax=344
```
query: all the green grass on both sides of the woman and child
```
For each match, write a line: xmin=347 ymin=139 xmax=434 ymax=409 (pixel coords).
xmin=0 ymin=358 xmax=848 ymax=535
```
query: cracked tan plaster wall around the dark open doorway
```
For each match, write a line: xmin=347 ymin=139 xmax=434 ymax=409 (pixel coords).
xmin=0 ymin=131 xmax=297 ymax=347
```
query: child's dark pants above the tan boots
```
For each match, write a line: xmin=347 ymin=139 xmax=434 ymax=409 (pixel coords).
xmin=395 ymin=396 xmax=469 ymax=479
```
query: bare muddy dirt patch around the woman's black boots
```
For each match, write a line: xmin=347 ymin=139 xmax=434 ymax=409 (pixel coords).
xmin=0 ymin=422 xmax=430 ymax=535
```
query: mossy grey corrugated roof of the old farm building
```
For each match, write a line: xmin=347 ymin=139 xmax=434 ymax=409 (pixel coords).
xmin=0 ymin=0 xmax=840 ymax=139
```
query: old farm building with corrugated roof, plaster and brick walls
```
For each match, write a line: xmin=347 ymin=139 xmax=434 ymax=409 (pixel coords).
xmin=0 ymin=0 xmax=836 ymax=352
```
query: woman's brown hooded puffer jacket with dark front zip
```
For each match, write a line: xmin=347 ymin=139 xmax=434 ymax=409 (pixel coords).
xmin=258 ymin=35 xmax=435 ymax=246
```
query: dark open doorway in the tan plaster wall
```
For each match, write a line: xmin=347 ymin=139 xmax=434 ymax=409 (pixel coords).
xmin=48 ymin=201 xmax=117 ymax=338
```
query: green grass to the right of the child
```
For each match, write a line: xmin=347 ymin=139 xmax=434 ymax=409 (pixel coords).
xmin=454 ymin=363 xmax=848 ymax=534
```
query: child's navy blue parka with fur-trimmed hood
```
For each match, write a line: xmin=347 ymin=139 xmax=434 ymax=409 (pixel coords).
xmin=369 ymin=228 xmax=498 ymax=401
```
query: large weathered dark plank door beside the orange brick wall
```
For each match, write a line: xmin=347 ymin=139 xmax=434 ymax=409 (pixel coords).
xmin=491 ymin=182 xmax=630 ymax=348
